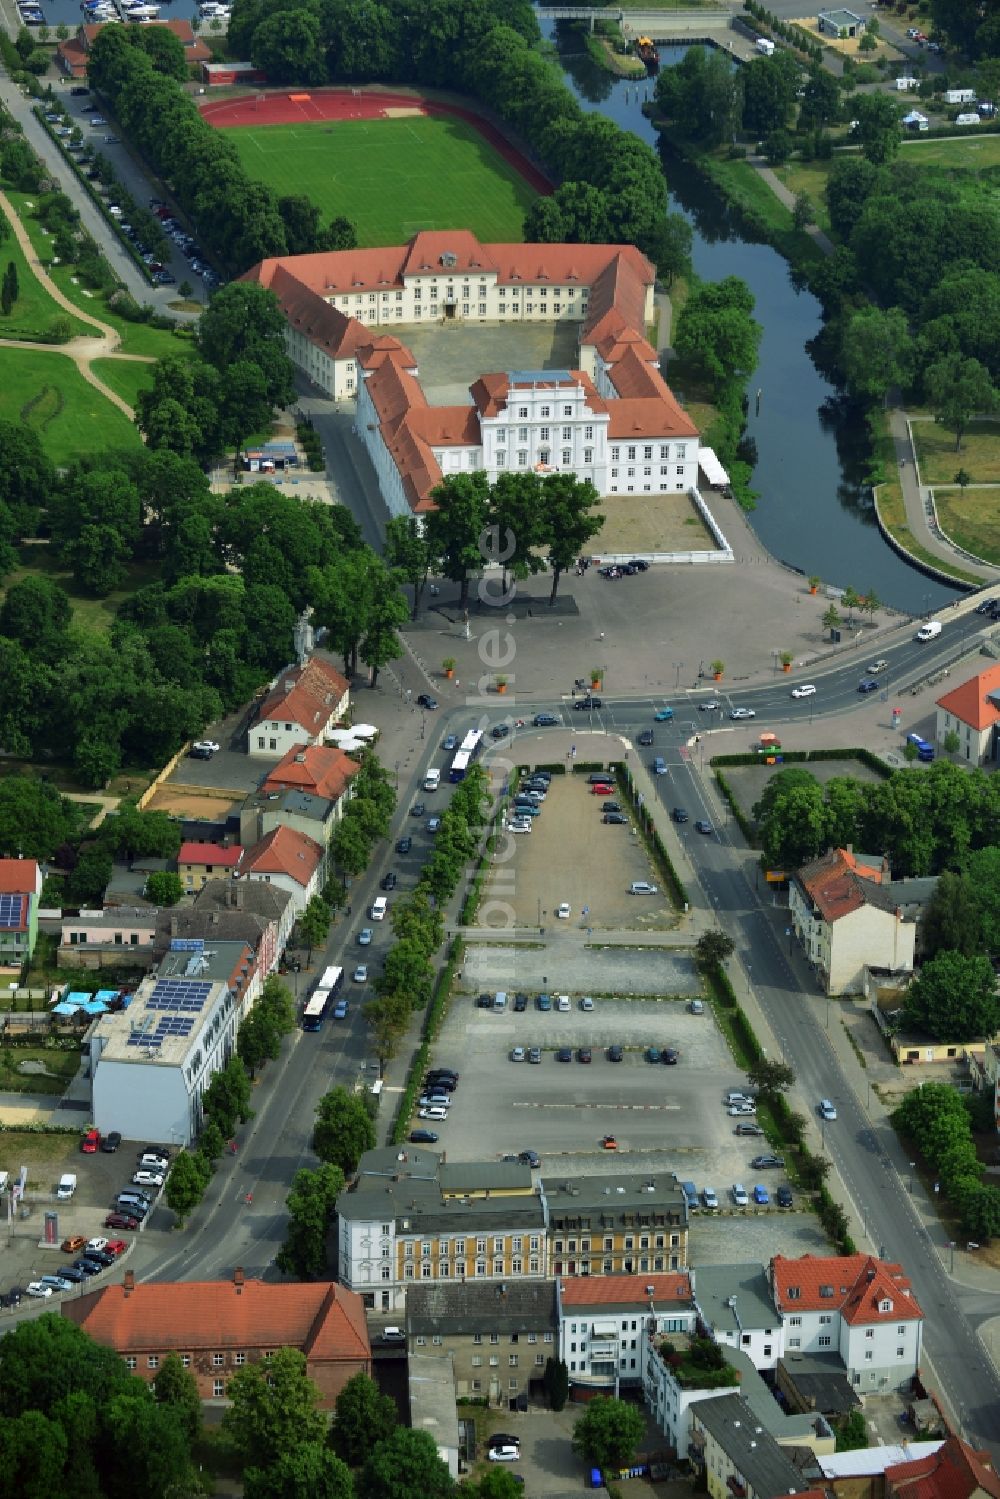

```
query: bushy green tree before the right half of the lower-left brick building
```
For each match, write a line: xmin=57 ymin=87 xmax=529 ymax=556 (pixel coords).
xmin=222 ymin=1348 xmax=327 ymax=1468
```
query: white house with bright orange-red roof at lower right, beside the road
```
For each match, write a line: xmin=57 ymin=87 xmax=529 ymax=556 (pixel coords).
xmin=769 ymin=1255 xmax=924 ymax=1394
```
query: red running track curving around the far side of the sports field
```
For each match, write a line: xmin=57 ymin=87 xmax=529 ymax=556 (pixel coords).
xmin=198 ymin=88 xmax=552 ymax=193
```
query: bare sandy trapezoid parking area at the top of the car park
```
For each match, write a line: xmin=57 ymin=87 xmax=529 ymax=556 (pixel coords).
xmin=481 ymin=775 xmax=676 ymax=932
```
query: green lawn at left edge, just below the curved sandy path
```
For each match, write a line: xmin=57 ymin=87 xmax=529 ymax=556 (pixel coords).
xmin=0 ymin=343 xmax=139 ymax=465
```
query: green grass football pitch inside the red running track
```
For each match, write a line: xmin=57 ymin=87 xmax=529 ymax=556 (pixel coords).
xmin=225 ymin=115 xmax=537 ymax=244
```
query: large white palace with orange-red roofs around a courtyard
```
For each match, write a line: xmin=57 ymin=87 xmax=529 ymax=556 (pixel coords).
xmin=246 ymin=229 xmax=699 ymax=516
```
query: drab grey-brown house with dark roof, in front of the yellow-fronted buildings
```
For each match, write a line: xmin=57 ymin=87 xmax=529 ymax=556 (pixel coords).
xmin=406 ymin=1280 xmax=558 ymax=1408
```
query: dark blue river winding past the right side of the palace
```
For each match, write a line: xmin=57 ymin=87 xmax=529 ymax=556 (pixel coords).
xmin=543 ymin=22 xmax=957 ymax=613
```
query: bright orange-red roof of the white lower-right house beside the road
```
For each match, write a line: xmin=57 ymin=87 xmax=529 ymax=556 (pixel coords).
xmin=771 ymin=1255 xmax=924 ymax=1325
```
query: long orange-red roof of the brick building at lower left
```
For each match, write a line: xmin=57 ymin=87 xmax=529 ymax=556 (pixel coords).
xmin=63 ymin=1271 xmax=370 ymax=1360
